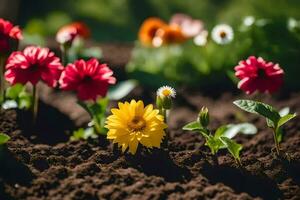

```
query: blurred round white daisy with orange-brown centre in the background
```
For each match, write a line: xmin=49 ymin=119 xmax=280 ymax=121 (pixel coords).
xmin=211 ymin=24 xmax=234 ymax=45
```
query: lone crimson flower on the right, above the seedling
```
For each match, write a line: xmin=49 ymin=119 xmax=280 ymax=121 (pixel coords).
xmin=234 ymin=56 xmax=284 ymax=94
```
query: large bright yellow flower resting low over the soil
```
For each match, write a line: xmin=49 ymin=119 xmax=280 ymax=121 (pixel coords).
xmin=105 ymin=100 xmax=167 ymax=154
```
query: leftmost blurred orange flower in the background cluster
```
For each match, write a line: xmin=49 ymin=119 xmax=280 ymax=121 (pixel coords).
xmin=139 ymin=17 xmax=167 ymax=46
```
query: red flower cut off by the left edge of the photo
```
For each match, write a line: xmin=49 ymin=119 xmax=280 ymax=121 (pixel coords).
xmin=0 ymin=18 xmax=22 ymax=54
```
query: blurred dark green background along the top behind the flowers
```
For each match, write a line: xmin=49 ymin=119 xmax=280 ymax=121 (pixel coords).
xmin=7 ymin=0 xmax=300 ymax=42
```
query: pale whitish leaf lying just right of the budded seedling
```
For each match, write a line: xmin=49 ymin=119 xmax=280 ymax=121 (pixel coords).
xmin=222 ymin=123 xmax=257 ymax=139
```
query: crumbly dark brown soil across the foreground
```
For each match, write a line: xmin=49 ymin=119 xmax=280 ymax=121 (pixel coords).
xmin=0 ymin=90 xmax=300 ymax=200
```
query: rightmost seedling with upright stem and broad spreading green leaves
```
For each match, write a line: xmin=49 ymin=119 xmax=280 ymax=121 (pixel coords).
xmin=233 ymin=100 xmax=297 ymax=155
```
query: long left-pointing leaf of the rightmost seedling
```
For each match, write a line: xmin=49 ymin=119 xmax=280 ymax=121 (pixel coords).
xmin=233 ymin=100 xmax=280 ymax=125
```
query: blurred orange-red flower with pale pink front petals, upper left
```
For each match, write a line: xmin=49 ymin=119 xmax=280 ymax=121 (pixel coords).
xmin=56 ymin=22 xmax=90 ymax=44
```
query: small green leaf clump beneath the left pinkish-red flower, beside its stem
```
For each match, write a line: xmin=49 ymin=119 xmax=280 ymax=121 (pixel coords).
xmin=3 ymin=84 xmax=32 ymax=109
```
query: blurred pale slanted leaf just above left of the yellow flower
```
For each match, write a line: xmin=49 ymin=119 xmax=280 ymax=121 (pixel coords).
xmin=107 ymin=80 xmax=138 ymax=100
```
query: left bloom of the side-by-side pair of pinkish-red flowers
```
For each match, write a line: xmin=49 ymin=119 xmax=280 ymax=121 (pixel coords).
xmin=5 ymin=46 xmax=64 ymax=87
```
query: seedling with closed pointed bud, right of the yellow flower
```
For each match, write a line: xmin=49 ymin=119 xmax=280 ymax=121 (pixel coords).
xmin=183 ymin=107 xmax=257 ymax=166
